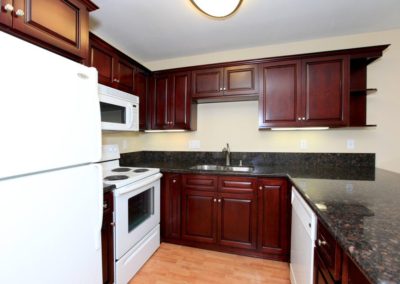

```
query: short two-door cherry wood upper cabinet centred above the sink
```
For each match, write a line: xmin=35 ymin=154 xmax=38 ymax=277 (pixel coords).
xmin=192 ymin=64 xmax=259 ymax=102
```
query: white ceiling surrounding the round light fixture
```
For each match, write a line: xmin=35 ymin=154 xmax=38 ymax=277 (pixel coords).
xmin=90 ymin=0 xmax=400 ymax=62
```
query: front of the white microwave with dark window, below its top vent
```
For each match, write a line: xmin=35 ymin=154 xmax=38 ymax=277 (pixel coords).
xmin=100 ymin=95 xmax=139 ymax=131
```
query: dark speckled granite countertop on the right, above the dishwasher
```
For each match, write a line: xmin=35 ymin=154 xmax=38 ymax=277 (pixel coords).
xmin=292 ymin=169 xmax=400 ymax=284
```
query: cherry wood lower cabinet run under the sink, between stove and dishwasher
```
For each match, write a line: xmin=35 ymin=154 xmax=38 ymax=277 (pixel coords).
xmin=161 ymin=173 xmax=290 ymax=261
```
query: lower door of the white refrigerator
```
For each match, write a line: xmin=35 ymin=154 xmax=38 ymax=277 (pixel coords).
xmin=0 ymin=165 xmax=103 ymax=284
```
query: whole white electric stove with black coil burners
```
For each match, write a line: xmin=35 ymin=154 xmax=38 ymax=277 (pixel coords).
xmin=101 ymin=145 xmax=162 ymax=284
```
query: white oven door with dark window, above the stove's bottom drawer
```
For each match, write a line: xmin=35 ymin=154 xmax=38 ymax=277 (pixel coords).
xmin=114 ymin=173 xmax=162 ymax=260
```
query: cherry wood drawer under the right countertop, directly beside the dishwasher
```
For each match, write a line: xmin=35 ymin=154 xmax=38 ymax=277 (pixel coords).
xmin=315 ymin=221 xmax=342 ymax=281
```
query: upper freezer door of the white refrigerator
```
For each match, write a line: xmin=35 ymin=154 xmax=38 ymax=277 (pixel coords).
xmin=0 ymin=32 xmax=101 ymax=179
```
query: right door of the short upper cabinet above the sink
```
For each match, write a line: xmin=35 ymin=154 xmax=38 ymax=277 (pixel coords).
xmin=223 ymin=64 xmax=259 ymax=96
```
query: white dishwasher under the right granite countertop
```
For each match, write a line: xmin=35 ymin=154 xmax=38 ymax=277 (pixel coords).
xmin=290 ymin=187 xmax=317 ymax=284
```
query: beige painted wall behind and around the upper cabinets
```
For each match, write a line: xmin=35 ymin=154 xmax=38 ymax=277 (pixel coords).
xmin=103 ymin=29 xmax=400 ymax=172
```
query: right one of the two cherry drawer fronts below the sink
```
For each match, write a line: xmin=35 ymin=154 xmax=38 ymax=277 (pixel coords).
xmin=219 ymin=177 xmax=257 ymax=193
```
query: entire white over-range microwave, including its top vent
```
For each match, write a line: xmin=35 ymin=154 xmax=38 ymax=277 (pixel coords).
xmin=99 ymin=84 xmax=139 ymax=131
